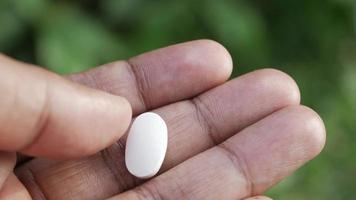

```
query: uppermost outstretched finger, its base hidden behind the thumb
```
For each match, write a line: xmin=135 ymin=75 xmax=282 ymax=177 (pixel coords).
xmin=70 ymin=40 xmax=232 ymax=114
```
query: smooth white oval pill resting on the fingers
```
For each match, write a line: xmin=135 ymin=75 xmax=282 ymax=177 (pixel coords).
xmin=125 ymin=112 xmax=168 ymax=178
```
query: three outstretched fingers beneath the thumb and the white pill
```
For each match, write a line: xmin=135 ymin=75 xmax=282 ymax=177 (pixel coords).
xmin=5 ymin=41 xmax=324 ymax=199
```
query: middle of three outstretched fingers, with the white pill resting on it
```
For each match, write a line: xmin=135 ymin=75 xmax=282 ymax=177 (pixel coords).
xmin=17 ymin=69 xmax=299 ymax=199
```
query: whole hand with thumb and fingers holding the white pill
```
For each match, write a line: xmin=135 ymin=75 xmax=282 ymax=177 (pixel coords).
xmin=0 ymin=40 xmax=325 ymax=200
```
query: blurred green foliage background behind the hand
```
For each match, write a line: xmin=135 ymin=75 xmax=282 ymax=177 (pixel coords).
xmin=0 ymin=0 xmax=356 ymax=200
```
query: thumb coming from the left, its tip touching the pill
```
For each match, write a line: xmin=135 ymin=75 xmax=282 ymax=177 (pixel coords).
xmin=0 ymin=56 xmax=131 ymax=158
